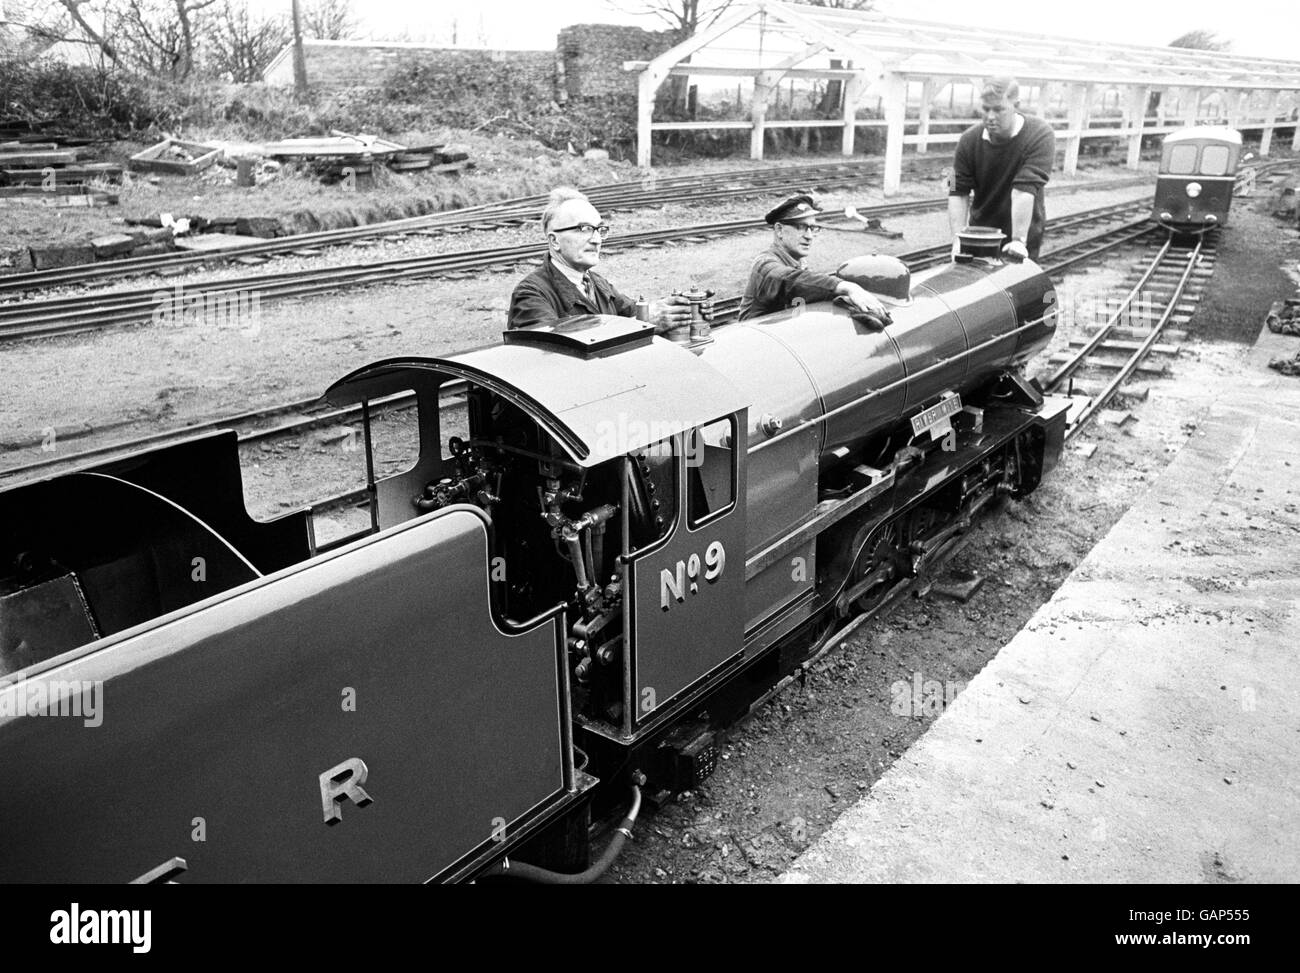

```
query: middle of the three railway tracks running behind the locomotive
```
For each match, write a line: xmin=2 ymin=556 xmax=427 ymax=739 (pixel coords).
xmin=0 ymin=196 xmax=1145 ymax=341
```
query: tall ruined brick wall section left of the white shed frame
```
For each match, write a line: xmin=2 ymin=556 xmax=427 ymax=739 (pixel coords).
xmin=555 ymin=23 xmax=676 ymax=99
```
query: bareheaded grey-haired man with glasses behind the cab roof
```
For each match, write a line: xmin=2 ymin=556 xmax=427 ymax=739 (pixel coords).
xmin=507 ymin=187 xmax=690 ymax=333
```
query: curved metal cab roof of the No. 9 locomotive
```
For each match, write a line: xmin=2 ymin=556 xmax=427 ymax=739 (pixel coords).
xmin=324 ymin=319 xmax=749 ymax=466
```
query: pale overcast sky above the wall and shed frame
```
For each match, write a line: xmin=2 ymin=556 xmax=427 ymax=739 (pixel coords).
xmin=332 ymin=0 xmax=1300 ymax=60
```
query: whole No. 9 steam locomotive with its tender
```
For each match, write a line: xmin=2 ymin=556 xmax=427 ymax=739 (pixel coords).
xmin=0 ymin=241 xmax=1067 ymax=882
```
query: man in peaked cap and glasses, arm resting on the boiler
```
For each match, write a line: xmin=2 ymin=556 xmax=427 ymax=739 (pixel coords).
xmin=740 ymin=193 xmax=889 ymax=321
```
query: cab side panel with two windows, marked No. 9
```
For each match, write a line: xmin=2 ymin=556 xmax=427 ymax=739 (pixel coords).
xmin=624 ymin=412 xmax=745 ymax=735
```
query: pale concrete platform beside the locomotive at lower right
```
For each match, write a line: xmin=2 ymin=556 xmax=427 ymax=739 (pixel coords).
xmin=781 ymin=325 xmax=1300 ymax=883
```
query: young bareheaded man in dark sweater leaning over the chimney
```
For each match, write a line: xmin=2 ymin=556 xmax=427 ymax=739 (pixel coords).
xmin=948 ymin=78 xmax=1056 ymax=260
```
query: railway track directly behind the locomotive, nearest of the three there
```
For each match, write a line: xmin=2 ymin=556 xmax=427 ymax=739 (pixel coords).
xmin=0 ymin=200 xmax=1157 ymax=483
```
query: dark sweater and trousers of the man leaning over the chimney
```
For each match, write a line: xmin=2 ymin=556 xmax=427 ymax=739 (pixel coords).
xmin=952 ymin=114 xmax=1056 ymax=260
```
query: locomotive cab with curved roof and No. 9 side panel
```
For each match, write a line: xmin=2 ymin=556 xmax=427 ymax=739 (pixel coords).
xmin=326 ymin=316 xmax=748 ymax=741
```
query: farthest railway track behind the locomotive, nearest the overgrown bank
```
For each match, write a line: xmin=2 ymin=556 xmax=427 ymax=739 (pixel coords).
xmin=0 ymin=156 xmax=944 ymax=295
